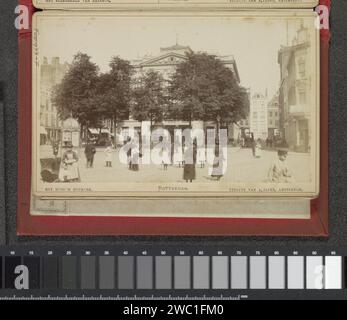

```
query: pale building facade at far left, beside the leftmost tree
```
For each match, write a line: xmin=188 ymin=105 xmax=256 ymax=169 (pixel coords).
xmin=40 ymin=57 xmax=68 ymax=144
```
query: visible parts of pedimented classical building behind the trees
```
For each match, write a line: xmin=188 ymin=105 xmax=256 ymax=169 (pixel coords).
xmin=116 ymin=43 xmax=249 ymax=144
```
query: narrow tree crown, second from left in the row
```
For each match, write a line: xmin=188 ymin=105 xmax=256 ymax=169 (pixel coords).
xmin=97 ymin=57 xmax=133 ymax=134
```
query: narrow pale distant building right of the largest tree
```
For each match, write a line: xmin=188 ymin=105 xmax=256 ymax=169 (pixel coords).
xmin=250 ymin=92 xmax=268 ymax=140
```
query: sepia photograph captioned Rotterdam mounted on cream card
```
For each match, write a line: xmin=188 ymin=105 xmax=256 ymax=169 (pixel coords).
xmin=32 ymin=10 xmax=319 ymax=198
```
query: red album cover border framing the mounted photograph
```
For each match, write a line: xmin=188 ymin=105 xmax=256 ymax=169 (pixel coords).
xmin=17 ymin=0 xmax=330 ymax=237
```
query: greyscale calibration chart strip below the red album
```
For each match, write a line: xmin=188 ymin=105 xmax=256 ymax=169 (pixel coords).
xmin=0 ymin=246 xmax=347 ymax=299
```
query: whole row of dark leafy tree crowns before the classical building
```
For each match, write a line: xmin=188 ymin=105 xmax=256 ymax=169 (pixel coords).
xmin=52 ymin=53 xmax=249 ymax=135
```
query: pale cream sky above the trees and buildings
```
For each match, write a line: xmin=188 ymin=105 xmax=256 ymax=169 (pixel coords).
xmin=38 ymin=16 xmax=311 ymax=99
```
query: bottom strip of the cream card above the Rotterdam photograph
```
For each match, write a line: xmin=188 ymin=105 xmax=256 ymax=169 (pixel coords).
xmin=33 ymin=0 xmax=318 ymax=10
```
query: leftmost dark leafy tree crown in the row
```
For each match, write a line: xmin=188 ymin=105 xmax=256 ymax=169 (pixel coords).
xmin=52 ymin=52 xmax=100 ymax=129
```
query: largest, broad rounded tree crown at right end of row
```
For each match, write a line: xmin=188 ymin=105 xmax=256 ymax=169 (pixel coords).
xmin=168 ymin=53 xmax=249 ymax=128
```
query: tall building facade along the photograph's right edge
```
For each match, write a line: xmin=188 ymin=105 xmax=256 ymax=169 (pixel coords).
xmin=278 ymin=26 xmax=313 ymax=152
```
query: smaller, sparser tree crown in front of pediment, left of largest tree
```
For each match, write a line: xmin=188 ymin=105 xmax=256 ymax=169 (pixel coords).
xmin=131 ymin=70 xmax=167 ymax=126
